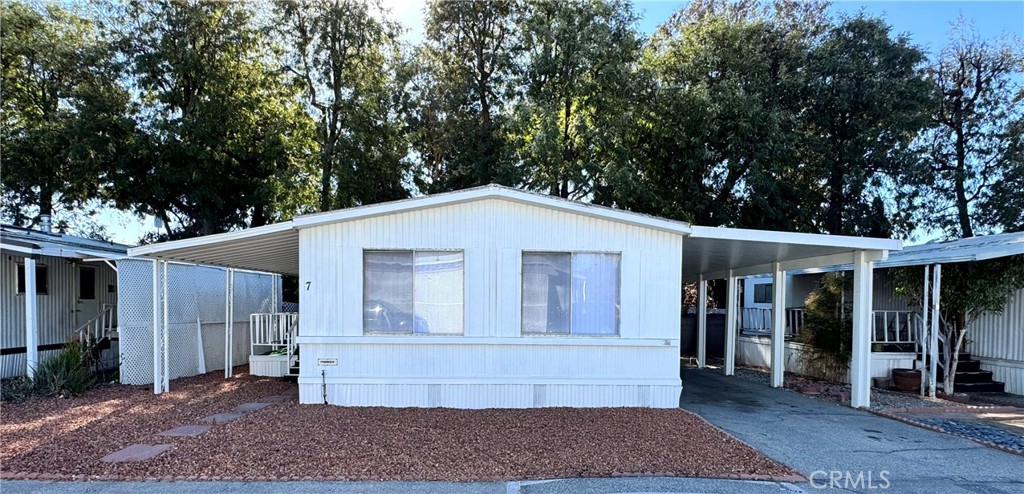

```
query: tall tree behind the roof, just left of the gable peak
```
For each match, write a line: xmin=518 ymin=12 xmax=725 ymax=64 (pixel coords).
xmin=408 ymin=0 xmax=522 ymax=193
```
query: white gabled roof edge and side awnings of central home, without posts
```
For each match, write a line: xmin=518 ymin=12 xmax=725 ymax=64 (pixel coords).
xmin=128 ymin=186 xmax=900 ymax=280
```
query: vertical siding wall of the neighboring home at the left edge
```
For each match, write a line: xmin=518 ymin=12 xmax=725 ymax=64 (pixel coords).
xmin=0 ymin=254 xmax=117 ymax=378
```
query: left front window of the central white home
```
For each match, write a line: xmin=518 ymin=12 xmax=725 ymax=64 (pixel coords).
xmin=362 ymin=250 xmax=464 ymax=334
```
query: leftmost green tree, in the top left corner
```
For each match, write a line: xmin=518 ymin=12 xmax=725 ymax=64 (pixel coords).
xmin=0 ymin=2 xmax=132 ymax=223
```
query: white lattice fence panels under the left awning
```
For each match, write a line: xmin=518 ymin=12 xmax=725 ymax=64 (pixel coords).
xmin=118 ymin=259 xmax=281 ymax=384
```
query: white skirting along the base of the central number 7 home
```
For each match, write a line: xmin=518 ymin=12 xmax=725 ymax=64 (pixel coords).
xmin=299 ymin=382 xmax=682 ymax=409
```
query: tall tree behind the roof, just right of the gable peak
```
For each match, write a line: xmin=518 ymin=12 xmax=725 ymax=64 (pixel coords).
xmin=511 ymin=0 xmax=641 ymax=199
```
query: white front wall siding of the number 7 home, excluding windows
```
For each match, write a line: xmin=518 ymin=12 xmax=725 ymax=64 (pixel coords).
xmin=299 ymin=199 xmax=682 ymax=408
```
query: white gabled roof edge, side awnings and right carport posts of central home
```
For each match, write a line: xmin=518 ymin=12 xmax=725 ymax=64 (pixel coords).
xmin=129 ymin=186 xmax=901 ymax=407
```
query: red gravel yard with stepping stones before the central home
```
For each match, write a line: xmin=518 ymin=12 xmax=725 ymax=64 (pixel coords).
xmin=0 ymin=373 xmax=796 ymax=481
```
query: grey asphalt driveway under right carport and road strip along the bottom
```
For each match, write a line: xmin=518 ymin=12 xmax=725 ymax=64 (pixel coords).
xmin=0 ymin=370 xmax=1024 ymax=494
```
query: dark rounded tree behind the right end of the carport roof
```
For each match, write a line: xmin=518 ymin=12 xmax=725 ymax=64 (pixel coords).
xmin=801 ymin=16 xmax=929 ymax=235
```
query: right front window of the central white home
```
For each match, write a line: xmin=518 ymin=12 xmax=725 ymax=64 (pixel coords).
xmin=522 ymin=252 xmax=621 ymax=335
